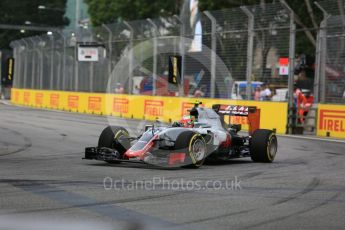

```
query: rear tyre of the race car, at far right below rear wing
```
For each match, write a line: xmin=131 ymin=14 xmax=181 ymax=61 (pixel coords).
xmin=249 ymin=129 xmax=278 ymax=163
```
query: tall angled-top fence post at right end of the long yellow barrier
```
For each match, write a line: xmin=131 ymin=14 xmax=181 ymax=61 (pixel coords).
xmin=280 ymin=0 xmax=298 ymax=134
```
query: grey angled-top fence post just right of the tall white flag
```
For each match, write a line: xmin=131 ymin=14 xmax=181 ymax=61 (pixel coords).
xmin=204 ymin=11 xmax=217 ymax=98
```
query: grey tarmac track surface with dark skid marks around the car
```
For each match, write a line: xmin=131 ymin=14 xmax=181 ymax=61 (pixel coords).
xmin=0 ymin=104 xmax=345 ymax=229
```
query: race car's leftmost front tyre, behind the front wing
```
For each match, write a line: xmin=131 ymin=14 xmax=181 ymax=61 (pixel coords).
xmin=98 ymin=126 xmax=130 ymax=163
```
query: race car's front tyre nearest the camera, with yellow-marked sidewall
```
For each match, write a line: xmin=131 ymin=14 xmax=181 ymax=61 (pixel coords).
xmin=175 ymin=131 xmax=207 ymax=168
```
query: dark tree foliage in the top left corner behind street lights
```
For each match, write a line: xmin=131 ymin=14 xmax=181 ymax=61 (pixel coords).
xmin=0 ymin=0 xmax=68 ymax=49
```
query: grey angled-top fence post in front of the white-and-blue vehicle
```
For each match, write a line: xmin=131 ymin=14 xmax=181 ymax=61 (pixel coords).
xmin=241 ymin=6 xmax=254 ymax=100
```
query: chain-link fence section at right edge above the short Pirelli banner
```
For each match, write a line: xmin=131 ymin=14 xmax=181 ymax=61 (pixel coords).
xmin=315 ymin=0 xmax=345 ymax=104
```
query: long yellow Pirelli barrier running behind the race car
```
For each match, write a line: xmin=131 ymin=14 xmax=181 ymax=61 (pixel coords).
xmin=11 ymin=89 xmax=288 ymax=134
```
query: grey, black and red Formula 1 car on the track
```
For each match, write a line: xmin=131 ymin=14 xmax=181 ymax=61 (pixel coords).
xmin=84 ymin=104 xmax=278 ymax=168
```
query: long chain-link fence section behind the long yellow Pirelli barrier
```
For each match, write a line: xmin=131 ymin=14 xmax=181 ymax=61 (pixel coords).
xmin=11 ymin=2 xmax=295 ymax=101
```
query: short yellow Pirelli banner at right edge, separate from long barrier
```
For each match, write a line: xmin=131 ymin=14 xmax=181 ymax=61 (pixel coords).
xmin=317 ymin=104 xmax=345 ymax=138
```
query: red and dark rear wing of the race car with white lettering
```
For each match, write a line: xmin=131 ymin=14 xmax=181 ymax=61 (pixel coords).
xmin=212 ymin=104 xmax=260 ymax=135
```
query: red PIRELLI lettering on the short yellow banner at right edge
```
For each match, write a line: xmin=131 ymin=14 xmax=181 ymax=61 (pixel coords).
xmin=319 ymin=109 xmax=345 ymax=133
